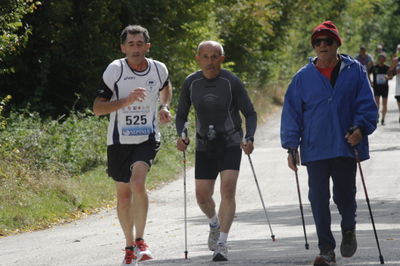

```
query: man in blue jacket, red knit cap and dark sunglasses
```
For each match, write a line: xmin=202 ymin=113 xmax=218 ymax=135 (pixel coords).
xmin=281 ymin=21 xmax=378 ymax=265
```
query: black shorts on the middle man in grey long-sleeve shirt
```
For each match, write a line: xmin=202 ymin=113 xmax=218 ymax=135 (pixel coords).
xmin=195 ymin=146 xmax=242 ymax=180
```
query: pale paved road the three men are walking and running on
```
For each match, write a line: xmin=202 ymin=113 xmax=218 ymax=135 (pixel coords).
xmin=0 ymin=82 xmax=400 ymax=266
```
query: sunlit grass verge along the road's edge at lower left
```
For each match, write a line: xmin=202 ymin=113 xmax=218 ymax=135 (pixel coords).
xmin=0 ymin=164 xmax=115 ymax=236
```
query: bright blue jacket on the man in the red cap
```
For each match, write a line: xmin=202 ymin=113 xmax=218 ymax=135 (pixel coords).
xmin=281 ymin=54 xmax=378 ymax=165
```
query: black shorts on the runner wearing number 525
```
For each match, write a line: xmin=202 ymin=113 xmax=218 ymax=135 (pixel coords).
xmin=107 ymin=139 xmax=160 ymax=183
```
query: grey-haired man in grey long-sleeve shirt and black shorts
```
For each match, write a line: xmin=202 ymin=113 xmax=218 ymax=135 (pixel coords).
xmin=176 ymin=41 xmax=257 ymax=261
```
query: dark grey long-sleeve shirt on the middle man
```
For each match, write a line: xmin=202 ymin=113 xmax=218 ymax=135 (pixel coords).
xmin=176 ymin=69 xmax=257 ymax=150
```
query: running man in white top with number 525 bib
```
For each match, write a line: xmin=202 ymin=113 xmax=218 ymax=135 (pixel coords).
xmin=93 ymin=25 xmax=172 ymax=265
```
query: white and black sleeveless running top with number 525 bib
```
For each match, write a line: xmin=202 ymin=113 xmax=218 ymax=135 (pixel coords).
xmin=103 ymin=59 xmax=168 ymax=145
